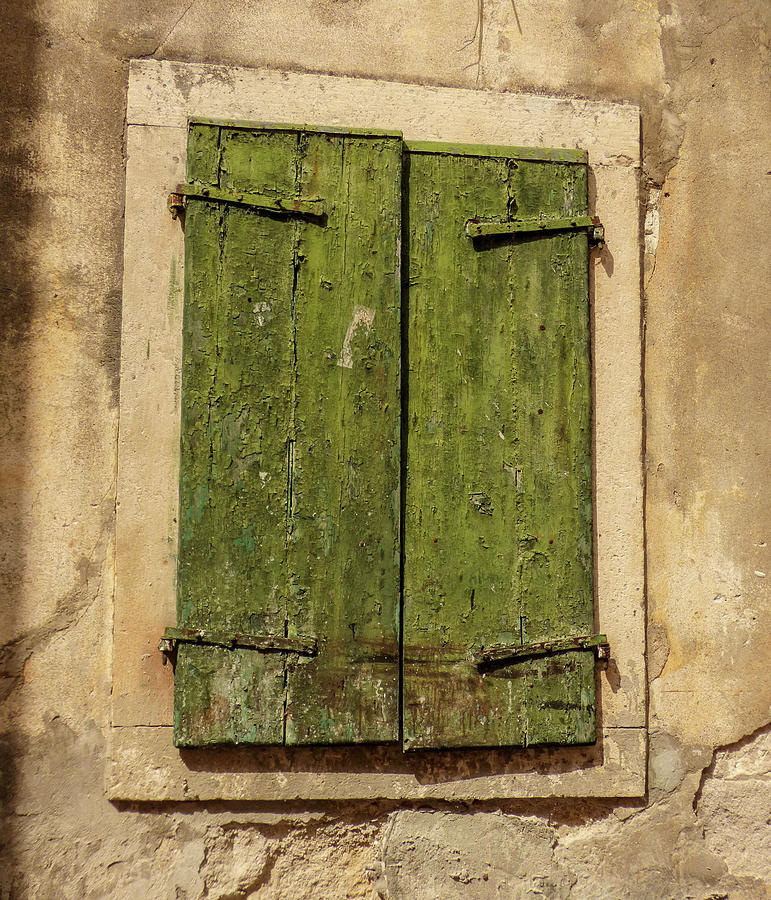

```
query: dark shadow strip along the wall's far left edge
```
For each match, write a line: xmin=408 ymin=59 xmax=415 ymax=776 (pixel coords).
xmin=0 ymin=0 xmax=44 ymax=884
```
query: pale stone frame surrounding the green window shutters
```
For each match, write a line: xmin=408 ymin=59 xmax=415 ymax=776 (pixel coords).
xmin=107 ymin=60 xmax=647 ymax=802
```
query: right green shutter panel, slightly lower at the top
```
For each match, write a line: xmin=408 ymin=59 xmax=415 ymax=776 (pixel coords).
xmin=403 ymin=144 xmax=595 ymax=748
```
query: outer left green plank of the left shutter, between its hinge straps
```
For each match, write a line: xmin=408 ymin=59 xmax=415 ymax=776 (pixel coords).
xmin=175 ymin=126 xmax=296 ymax=746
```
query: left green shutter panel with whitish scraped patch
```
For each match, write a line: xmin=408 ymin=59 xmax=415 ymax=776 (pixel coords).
xmin=175 ymin=123 xmax=401 ymax=746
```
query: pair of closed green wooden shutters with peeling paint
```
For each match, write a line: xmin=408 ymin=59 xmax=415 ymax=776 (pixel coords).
xmin=164 ymin=121 xmax=602 ymax=749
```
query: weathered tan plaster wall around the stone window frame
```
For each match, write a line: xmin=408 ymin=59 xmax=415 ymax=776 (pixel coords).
xmin=0 ymin=0 xmax=771 ymax=900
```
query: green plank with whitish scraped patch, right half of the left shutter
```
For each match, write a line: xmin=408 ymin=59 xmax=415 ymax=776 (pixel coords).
xmin=286 ymin=134 xmax=402 ymax=744
